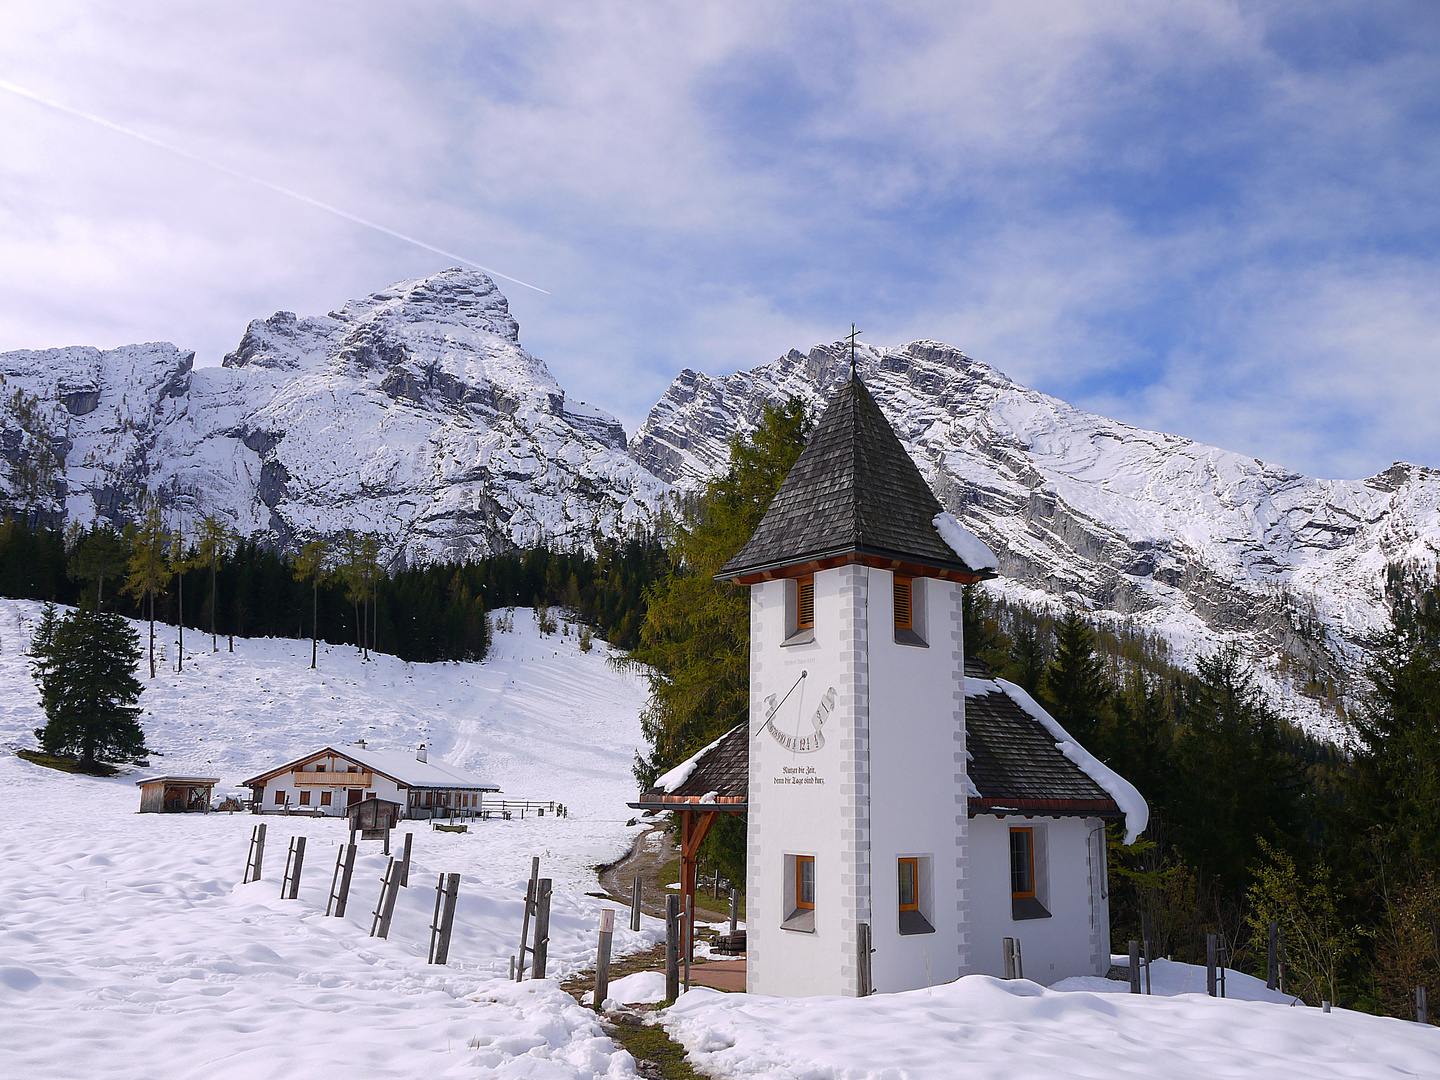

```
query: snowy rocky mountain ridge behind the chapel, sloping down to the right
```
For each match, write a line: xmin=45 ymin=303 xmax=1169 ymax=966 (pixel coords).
xmin=631 ymin=341 xmax=1440 ymax=737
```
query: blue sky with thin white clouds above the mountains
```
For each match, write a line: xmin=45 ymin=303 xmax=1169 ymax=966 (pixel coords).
xmin=0 ymin=0 xmax=1440 ymax=477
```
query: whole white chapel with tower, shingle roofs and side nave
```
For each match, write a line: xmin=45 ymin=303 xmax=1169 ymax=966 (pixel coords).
xmin=632 ymin=376 xmax=1148 ymax=996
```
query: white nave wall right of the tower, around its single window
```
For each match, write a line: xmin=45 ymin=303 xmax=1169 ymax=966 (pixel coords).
xmin=969 ymin=815 xmax=1110 ymax=985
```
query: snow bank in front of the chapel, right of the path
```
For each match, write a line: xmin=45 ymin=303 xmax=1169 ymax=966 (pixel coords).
xmin=665 ymin=963 xmax=1440 ymax=1080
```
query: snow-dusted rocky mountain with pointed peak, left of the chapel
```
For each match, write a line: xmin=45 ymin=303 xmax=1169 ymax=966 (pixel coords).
xmin=0 ymin=269 xmax=668 ymax=563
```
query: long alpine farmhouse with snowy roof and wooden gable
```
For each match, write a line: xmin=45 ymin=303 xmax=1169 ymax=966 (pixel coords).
xmin=245 ymin=739 xmax=500 ymax=818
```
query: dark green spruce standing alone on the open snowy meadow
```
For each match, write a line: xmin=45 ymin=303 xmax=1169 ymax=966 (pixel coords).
xmin=32 ymin=611 xmax=148 ymax=768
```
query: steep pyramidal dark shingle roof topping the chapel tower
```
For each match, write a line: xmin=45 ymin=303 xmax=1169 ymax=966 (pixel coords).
xmin=716 ymin=377 xmax=991 ymax=580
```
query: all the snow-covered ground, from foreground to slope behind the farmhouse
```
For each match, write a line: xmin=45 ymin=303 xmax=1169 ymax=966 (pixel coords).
xmin=0 ymin=600 xmax=1440 ymax=1080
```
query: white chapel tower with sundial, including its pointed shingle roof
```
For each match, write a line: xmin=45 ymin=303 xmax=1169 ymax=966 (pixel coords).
xmin=719 ymin=372 xmax=994 ymax=996
